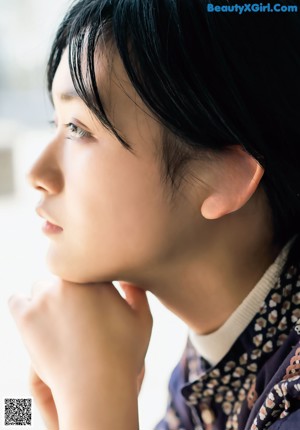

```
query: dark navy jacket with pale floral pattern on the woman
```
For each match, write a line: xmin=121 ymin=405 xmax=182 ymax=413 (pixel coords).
xmin=155 ymin=239 xmax=300 ymax=430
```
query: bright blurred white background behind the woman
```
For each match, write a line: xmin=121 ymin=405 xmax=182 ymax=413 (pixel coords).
xmin=0 ymin=0 xmax=187 ymax=430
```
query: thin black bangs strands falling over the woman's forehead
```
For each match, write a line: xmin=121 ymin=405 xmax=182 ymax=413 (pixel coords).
xmin=47 ymin=1 xmax=133 ymax=151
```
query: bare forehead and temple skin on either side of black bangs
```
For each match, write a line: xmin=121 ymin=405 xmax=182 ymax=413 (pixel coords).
xmin=52 ymin=49 xmax=162 ymax=152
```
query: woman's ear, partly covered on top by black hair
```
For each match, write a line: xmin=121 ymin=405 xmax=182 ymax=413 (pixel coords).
xmin=201 ymin=145 xmax=264 ymax=219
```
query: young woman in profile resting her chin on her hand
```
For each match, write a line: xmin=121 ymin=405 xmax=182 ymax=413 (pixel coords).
xmin=9 ymin=0 xmax=300 ymax=430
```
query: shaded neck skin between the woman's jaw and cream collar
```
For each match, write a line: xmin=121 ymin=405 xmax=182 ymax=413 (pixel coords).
xmin=130 ymin=190 xmax=280 ymax=334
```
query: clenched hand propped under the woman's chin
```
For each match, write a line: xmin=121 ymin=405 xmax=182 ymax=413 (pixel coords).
xmin=9 ymin=281 xmax=152 ymax=428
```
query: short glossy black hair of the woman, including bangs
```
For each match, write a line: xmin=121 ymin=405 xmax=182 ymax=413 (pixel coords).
xmin=48 ymin=0 xmax=300 ymax=244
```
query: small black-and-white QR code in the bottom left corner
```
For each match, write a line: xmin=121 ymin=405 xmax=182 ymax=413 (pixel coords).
xmin=4 ymin=399 xmax=32 ymax=426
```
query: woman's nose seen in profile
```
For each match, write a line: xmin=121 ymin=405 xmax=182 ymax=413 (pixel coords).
xmin=27 ymin=144 xmax=64 ymax=195
